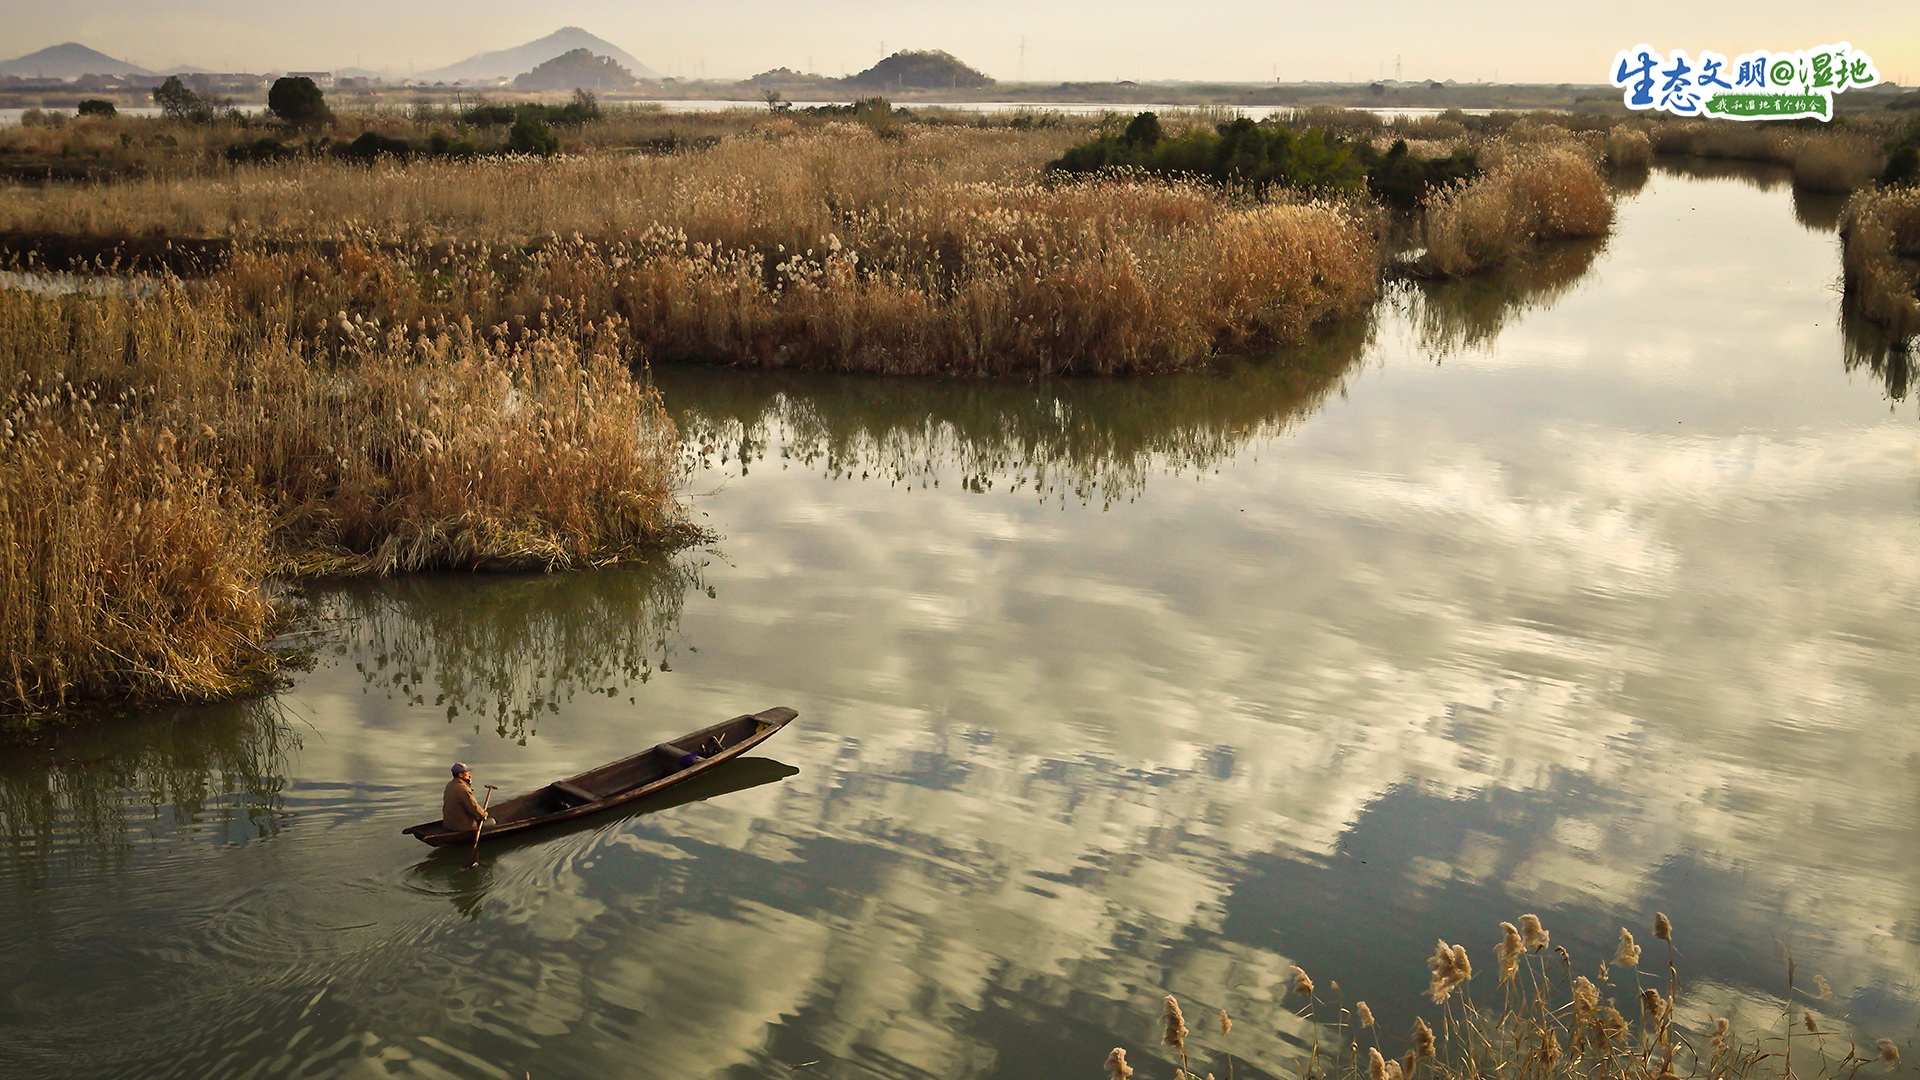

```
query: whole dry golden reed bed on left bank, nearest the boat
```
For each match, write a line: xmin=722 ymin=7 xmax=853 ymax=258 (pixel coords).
xmin=0 ymin=288 xmax=684 ymax=713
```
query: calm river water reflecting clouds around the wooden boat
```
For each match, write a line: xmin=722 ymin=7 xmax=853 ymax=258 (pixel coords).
xmin=0 ymin=171 xmax=1920 ymax=1080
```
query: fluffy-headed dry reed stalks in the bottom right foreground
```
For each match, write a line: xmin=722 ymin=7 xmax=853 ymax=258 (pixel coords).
xmin=1136 ymin=913 xmax=1901 ymax=1080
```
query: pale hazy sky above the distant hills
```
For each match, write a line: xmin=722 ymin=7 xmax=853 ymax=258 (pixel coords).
xmin=0 ymin=0 xmax=1920 ymax=85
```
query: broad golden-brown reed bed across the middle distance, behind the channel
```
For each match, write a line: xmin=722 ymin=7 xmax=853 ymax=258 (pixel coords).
xmin=0 ymin=125 xmax=1379 ymax=375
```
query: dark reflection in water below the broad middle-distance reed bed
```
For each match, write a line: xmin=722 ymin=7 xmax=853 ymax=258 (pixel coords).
xmin=655 ymin=311 xmax=1373 ymax=505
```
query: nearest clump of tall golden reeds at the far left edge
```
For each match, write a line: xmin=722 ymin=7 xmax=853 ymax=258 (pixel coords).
xmin=0 ymin=384 xmax=273 ymax=711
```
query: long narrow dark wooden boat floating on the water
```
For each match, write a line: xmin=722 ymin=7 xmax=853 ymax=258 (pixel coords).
xmin=401 ymin=705 xmax=799 ymax=847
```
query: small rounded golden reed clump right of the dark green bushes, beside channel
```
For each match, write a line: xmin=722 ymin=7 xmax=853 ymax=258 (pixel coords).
xmin=1427 ymin=148 xmax=1613 ymax=277
